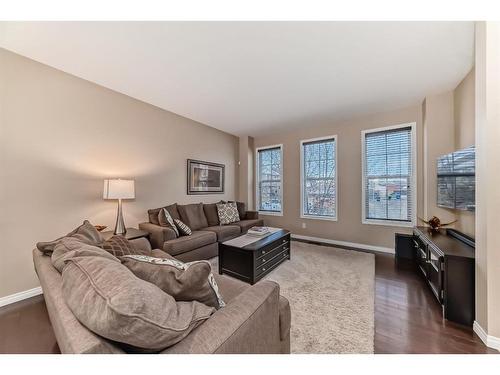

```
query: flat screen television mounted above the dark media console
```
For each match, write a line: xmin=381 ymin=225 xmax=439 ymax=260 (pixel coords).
xmin=437 ymin=146 xmax=476 ymax=211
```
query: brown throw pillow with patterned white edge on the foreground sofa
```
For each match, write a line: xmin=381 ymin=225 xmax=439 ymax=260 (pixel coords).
xmin=120 ymin=255 xmax=225 ymax=309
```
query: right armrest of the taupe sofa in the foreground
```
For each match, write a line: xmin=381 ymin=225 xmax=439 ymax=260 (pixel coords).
xmin=163 ymin=280 xmax=281 ymax=354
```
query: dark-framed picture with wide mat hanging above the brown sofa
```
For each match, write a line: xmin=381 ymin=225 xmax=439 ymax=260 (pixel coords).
xmin=187 ymin=159 xmax=225 ymax=195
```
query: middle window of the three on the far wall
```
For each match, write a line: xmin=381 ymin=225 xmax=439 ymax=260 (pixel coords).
xmin=300 ymin=136 xmax=337 ymax=220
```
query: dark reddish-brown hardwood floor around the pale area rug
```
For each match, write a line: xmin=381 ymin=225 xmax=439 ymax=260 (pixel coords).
xmin=0 ymin=253 xmax=498 ymax=353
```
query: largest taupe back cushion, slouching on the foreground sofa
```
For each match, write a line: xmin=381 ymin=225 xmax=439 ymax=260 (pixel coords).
xmin=62 ymin=256 xmax=215 ymax=351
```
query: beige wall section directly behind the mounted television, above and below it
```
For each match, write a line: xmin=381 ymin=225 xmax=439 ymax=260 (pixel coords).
xmin=453 ymin=69 xmax=476 ymax=236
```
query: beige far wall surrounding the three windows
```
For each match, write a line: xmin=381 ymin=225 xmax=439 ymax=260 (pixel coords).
xmin=255 ymin=105 xmax=423 ymax=248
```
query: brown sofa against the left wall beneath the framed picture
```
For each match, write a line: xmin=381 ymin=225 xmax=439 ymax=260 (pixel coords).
xmin=139 ymin=202 xmax=264 ymax=262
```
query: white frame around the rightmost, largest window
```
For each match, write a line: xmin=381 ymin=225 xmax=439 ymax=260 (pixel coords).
xmin=361 ymin=122 xmax=417 ymax=228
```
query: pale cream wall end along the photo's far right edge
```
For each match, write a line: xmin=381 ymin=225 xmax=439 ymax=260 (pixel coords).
xmin=475 ymin=22 xmax=500 ymax=345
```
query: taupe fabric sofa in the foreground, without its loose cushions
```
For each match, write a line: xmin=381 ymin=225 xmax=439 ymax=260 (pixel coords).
xmin=33 ymin=238 xmax=290 ymax=354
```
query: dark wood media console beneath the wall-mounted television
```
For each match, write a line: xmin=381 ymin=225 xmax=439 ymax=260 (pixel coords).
xmin=396 ymin=227 xmax=475 ymax=326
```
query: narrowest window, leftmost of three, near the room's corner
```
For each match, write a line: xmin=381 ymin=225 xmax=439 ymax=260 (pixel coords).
xmin=257 ymin=145 xmax=283 ymax=215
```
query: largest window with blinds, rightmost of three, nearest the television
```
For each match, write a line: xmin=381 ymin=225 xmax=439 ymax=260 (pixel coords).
xmin=362 ymin=123 xmax=416 ymax=226
